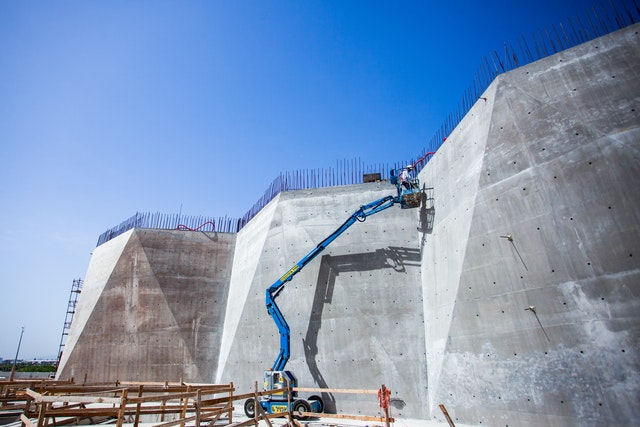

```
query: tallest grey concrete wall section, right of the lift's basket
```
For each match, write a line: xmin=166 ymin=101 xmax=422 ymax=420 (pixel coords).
xmin=420 ymin=25 xmax=640 ymax=426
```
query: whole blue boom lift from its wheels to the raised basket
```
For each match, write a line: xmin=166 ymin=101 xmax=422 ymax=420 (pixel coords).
xmin=244 ymin=168 xmax=422 ymax=418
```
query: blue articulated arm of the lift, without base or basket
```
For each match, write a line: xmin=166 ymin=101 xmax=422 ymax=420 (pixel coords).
xmin=266 ymin=196 xmax=401 ymax=371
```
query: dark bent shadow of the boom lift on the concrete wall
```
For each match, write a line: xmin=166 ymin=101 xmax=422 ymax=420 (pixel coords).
xmin=302 ymin=246 xmax=420 ymax=413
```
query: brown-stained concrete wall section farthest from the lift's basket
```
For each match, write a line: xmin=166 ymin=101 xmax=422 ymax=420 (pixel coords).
xmin=57 ymin=229 xmax=235 ymax=382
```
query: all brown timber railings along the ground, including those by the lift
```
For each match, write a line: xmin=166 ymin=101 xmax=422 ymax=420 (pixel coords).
xmin=0 ymin=380 xmax=393 ymax=427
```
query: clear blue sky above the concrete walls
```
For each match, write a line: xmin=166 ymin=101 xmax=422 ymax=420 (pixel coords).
xmin=0 ymin=0 xmax=600 ymax=359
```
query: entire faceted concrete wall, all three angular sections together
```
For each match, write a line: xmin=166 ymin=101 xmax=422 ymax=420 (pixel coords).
xmin=57 ymin=25 xmax=640 ymax=426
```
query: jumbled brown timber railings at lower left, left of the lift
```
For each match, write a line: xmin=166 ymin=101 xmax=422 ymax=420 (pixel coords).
xmin=0 ymin=381 xmax=237 ymax=427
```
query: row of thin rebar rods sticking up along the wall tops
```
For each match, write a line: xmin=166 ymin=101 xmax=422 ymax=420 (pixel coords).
xmin=98 ymin=0 xmax=640 ymax=246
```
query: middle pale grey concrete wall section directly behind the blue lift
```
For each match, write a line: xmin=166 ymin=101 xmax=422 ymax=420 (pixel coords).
xmin=217 ymin=182 xmax=427 ymax=417
